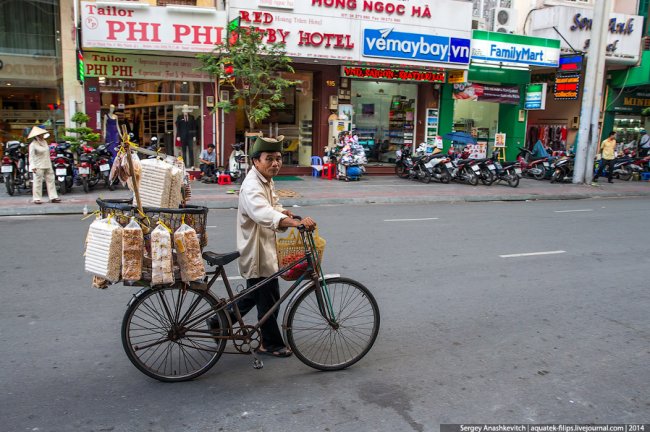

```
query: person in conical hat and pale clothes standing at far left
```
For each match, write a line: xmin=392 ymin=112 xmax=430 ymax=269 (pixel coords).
xmin=27 ymin=126 xmax=61 ymax=204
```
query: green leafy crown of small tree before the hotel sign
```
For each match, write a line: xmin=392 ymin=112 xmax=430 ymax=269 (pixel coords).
xmin=197 ymin=24 xmax=296 ymax=130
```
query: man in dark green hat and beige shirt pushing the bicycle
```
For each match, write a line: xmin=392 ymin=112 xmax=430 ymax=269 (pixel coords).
xmin=232 ymin=136 xmax=316 ymax=357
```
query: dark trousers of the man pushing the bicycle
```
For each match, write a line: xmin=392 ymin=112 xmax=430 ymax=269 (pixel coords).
xmin=237 ymin=278 xmax=285 ymax=351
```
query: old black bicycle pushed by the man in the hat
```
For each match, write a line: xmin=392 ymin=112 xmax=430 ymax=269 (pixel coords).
xmin=121 ymin=226 xmax=380 ymax=382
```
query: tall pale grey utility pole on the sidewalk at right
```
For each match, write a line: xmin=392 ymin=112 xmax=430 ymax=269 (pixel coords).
xmin=573 ymin=0 xmax=611 ymax=184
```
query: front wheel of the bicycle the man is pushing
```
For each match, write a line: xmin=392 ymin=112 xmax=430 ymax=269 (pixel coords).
xmin=286 ymin=278 xmax=379 ymax=371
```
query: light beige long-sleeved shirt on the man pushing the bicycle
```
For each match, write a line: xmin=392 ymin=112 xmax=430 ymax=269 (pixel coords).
xmin=237 ymin=167 xmax=287 ymax=279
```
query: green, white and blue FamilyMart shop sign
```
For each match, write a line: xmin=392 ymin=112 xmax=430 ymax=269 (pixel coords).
xmin=472 ymin=30 xmax=560 ymax=67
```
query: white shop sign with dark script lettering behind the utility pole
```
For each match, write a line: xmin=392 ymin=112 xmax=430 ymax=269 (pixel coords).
xmin=531 ymin=6 xmax=643 ymax=65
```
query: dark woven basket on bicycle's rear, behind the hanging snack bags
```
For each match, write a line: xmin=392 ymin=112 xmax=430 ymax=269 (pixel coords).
xmin=97 ymin=198 xmax=208 ymax=281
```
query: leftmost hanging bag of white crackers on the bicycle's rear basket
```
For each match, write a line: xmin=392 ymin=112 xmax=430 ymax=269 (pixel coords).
xmin=84 ymin=217 xmax=123 ymax=282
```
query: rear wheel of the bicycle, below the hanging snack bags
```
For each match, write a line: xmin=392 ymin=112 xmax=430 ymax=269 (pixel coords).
xmin=122 ymin=286 xmax=229 ymax=382
